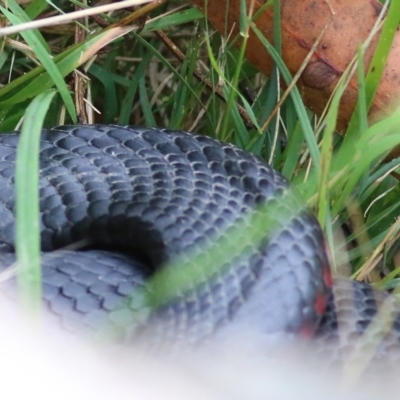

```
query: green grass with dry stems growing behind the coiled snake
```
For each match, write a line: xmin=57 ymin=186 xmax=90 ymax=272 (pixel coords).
xmin=0 ymin=0 xmax=400 ymax=350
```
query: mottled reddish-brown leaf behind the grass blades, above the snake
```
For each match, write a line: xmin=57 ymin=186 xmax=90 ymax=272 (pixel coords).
xmin=192 ymin=0 xmax=400 ymax=130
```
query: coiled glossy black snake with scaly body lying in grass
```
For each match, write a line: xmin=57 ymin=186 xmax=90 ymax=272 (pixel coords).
xmin=0 ymin=125 xmax=400 ymax=372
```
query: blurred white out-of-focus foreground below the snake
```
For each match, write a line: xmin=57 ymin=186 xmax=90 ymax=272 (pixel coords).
xmin=0 ymin=312 xmax=399 ymax=400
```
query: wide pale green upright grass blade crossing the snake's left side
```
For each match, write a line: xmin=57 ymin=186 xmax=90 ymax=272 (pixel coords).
xmin=15 ymin=90 xmax=56 ymax=314
